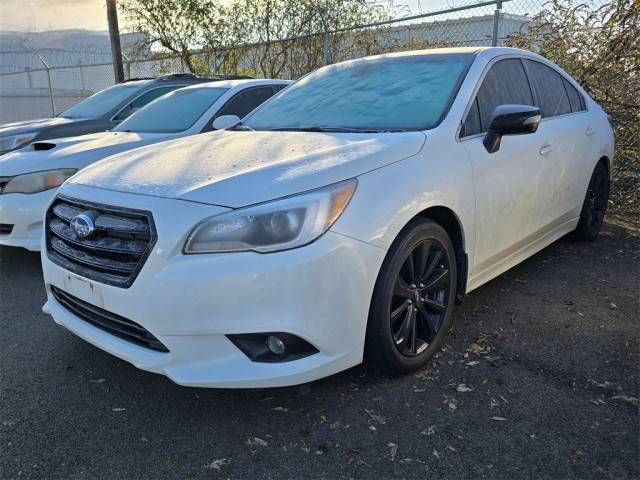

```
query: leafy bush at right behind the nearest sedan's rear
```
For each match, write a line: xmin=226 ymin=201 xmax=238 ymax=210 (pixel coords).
xmin=506 ymin=0 xmax=640 ymax=212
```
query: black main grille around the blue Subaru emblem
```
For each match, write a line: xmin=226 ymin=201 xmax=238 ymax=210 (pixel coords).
xmin=46 ymin=197 xmax=156 ymax=288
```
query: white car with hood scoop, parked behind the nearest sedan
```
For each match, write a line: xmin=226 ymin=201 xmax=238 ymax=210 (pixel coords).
xmin=0 ymin=80 xmax=291 ymax=251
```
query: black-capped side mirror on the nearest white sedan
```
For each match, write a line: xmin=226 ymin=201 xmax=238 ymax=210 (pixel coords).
xmin=482 ymin=105 xmax=542 ymax=153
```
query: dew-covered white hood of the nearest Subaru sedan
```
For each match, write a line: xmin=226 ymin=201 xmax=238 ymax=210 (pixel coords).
xmin=69 ymin=131 xmax=426 ymax=208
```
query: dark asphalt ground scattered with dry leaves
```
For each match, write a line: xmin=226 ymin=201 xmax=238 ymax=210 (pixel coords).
xmin=0 ymin=219 xmax=640 ymax=479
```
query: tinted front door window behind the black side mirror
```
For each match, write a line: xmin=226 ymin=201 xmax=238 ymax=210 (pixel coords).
xmin=464 ymin=58 xmax=533 ymax=136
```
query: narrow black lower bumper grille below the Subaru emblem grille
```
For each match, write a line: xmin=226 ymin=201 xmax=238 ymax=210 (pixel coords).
xmin=51 ymin=285 xmax=169 ymax=352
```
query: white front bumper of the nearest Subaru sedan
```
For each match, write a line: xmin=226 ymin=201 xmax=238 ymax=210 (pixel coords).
xmin=42 ymin=186 xmax=385 ymax=387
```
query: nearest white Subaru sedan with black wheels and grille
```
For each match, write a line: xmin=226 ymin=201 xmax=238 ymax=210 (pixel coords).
xmin=42 ymin=48 xmax=614 ymax=387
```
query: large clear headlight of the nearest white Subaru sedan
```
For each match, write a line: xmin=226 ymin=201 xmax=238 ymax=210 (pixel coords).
xmin=184 ymin=179 xmax=358 ymax=254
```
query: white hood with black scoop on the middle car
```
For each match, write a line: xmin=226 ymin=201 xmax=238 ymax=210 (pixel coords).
xmin=0 ymin=132 xmax=170 ymax=177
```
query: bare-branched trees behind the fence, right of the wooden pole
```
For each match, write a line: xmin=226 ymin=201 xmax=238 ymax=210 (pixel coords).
xmin=120 ymin=0 xmax=386 ymax=78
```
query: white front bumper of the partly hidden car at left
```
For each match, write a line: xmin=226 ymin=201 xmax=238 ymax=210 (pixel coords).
xmin=0 ymin=188 xmax=58 ymax=252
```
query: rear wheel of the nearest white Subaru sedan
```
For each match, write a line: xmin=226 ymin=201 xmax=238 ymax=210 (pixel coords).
xmin=574 ymin=162 xmax=609 ymax=242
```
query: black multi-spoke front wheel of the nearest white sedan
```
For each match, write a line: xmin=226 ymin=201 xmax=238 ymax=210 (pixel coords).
xmin=365 ymin=218 xmax=457 ymax=374
